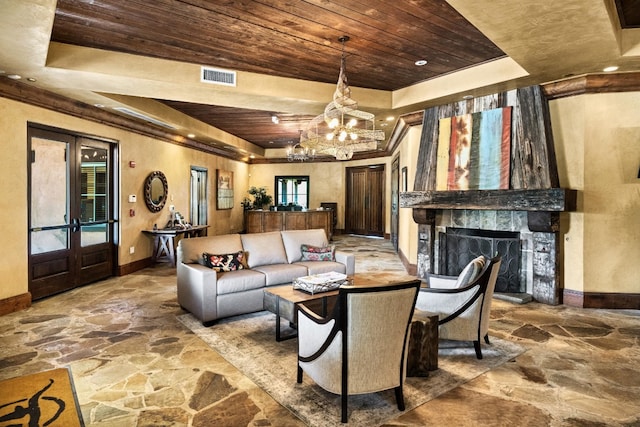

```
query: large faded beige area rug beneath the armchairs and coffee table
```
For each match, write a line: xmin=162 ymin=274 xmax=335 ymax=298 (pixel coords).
xmin=178 ymin=311 xmax=525 ymax=427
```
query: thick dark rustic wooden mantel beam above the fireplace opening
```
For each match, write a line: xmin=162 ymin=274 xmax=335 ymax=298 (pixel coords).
xmin=400 ymin=188 xmax=577 ymax=212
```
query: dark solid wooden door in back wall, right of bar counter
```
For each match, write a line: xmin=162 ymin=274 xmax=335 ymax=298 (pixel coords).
xmin=345 ymin=165 xmax=385 ymax=237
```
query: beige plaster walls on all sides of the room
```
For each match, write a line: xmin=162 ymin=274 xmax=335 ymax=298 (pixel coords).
xmin=0 ymin=92 xmax=640 ymax=299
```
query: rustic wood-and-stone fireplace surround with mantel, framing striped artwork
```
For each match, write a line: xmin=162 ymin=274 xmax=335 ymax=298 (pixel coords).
xmin=400 ymin=86 xmax=576 ymax=305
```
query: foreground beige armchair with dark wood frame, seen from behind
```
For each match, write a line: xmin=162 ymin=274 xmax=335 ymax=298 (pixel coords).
xmin=297 ymin=280 xmax=421 ymax=422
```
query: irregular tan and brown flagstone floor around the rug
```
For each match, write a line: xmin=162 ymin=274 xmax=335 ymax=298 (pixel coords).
xmin=0 ymin=236 xmax=640 ymax=427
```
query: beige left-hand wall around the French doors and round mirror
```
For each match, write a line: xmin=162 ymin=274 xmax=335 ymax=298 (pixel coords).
xmin=0 ymin=98 xmax=249 ymax=299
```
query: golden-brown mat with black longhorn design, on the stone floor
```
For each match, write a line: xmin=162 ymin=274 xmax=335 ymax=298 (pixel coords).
xmin=0 ymin=368 xmax=84 ymax=427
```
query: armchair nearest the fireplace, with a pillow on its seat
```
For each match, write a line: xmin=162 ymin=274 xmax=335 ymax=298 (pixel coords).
xmin=416 ymin=256 xmax=502 ymax=359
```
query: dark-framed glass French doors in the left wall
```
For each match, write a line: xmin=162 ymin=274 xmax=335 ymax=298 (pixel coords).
xmin=28 ymin=125 xmax=117 ymax=300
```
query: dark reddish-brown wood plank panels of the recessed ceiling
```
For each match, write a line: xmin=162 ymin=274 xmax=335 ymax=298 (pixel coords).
xmin=52 ymin=0 xmax=505 ymax=152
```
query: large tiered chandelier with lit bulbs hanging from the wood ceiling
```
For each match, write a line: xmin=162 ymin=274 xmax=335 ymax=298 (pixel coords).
xmin=300 ymin=36 xmax=385 ymax=160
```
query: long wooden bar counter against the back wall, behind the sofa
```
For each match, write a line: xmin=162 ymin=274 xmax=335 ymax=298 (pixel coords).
xmin=244 ymin=209 xmax=333 ymax=240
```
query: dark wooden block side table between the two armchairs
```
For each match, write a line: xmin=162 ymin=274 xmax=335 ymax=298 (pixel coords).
xmin=407 ymin=310 xmax=438 ymax=377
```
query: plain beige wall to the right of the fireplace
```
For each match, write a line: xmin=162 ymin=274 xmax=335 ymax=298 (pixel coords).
xmin=550 ymin=92 xmax=640 ymax=294
